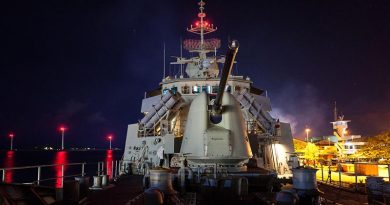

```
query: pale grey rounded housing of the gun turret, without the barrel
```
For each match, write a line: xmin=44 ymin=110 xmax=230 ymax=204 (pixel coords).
xmin=180 ymin=93 xmax=252 ymax=171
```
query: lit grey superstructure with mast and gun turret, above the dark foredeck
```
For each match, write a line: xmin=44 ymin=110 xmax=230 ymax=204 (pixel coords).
xmin=123 ymin=1 xmax=293 ymax=173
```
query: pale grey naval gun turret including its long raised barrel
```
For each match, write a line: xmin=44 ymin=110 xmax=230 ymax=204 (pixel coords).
xmin=180 ymin=41 xmax=252 ymax=172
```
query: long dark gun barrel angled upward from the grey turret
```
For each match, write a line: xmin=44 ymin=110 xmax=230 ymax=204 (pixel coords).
xmin=212 ymin=40 xmax=239 ymax=115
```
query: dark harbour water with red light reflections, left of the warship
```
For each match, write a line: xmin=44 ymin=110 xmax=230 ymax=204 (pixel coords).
xmin=0 ymin=150 xmax=123 ymax=186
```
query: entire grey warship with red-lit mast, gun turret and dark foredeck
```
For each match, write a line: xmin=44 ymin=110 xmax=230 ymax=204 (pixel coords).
xmin=122 ymin=0 xmax=304 ymax=202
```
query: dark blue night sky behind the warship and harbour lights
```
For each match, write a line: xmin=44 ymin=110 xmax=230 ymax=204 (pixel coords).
xmin=0 ymin=0 xmax=390 ymax=149
